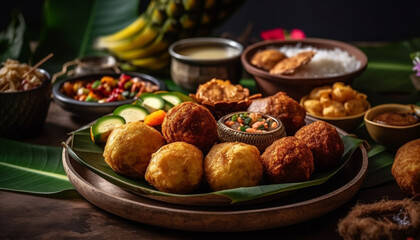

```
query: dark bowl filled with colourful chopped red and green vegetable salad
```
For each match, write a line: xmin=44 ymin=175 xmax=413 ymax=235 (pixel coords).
xmin=52 ymin=72 xmax=166 ymax=119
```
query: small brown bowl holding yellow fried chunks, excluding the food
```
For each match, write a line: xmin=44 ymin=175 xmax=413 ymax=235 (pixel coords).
xmin=300 ymin=96 xmax=370 ymax=132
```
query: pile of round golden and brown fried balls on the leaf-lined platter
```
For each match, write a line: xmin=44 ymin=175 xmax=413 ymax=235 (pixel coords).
xmin=103 ymin=80 xmax=344 ymax=194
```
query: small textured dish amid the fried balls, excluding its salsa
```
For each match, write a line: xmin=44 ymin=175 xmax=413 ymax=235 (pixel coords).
xmin=217 ymin=112 xmax=286 ymax=153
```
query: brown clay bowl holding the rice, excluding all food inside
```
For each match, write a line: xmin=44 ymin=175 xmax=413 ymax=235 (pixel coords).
xmin=241 ymin=38 xmax=368 ymax=101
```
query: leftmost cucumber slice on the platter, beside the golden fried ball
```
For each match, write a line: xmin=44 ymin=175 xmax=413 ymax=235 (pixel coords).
xmin=90 ymin=115 xmax=125 ymax=143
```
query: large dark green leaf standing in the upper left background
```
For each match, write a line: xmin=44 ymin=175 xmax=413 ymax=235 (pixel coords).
xmin=34 ymin=0 xmax=140 ymax=74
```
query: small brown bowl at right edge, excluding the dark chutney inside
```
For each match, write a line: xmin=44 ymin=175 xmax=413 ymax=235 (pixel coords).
xmin=364 ymin=104 xmax=420 ymax=150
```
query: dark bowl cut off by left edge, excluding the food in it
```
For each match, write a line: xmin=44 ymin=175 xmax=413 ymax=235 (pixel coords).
xmin=0 ymin=69 xmax=52 ymax=139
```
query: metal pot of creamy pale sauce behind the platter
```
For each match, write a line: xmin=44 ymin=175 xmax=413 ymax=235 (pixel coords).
xmin=169 ymin=37 xmax=243 ymax=90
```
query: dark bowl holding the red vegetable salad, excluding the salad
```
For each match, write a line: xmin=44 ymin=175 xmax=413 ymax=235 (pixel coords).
xmin=52 ymin=72 xmax=166 ymax=120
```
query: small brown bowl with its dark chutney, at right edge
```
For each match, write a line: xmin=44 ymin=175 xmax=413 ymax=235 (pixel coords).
xmin=364 ymin=104 xmax=420 ymax=150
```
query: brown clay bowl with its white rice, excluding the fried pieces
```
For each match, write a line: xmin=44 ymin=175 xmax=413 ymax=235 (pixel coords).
xmin=241 ymin=38 xmax=368 ymax=101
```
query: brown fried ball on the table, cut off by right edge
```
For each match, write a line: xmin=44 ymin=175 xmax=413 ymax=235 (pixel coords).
xmin=391 ymin=138 xmax=420 ymax=199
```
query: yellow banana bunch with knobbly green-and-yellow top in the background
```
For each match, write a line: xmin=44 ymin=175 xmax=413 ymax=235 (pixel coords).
xmin=95 ymin=0 xmax=244 ymax=70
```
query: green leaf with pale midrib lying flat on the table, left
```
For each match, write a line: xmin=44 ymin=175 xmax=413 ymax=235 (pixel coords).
xmin=0 ymin=138 xmax=74 ymax=194
